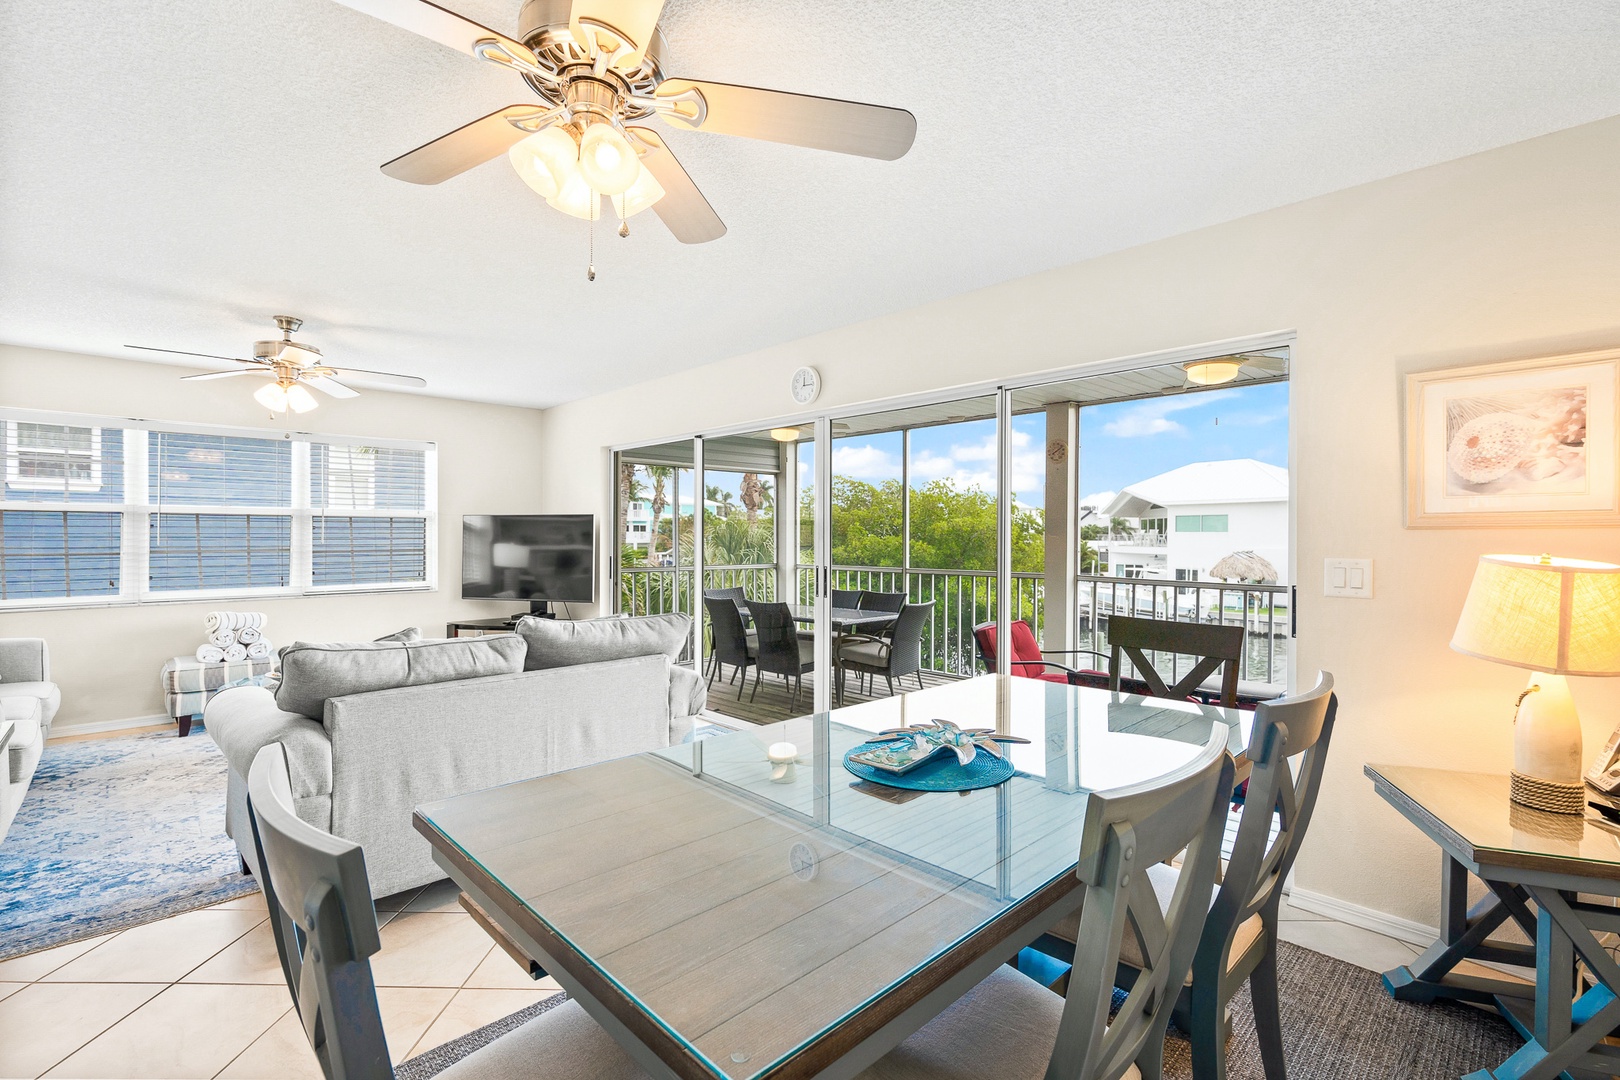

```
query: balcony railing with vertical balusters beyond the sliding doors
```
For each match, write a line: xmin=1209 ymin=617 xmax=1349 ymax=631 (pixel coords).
xmin=619 ymin=565 xmax=1290 ymax=687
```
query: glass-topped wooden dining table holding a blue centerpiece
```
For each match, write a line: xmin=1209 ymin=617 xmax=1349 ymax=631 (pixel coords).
xmin=415 ymin=675 xmax=1254 ymax=1080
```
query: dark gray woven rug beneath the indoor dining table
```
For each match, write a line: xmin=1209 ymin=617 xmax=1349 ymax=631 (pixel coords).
xmin=394 ymin=942 xmax=1520 ymax=1080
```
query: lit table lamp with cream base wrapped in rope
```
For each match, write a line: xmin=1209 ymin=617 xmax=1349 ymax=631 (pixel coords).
xmin=1452 ymin=555 xmax=1620 ymax=814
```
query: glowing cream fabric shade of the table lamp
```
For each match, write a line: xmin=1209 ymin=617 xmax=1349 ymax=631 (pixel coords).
xmin=1452 ymin=555 xmax=1620 ymax=675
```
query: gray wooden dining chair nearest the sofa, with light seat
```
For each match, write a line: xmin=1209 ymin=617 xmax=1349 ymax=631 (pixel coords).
xmin=248 ymin=743 xmax=646 ymax=1080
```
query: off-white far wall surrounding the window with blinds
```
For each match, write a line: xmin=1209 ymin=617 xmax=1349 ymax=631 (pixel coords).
xmin=0 ymin=345 xmax=541 ymax=733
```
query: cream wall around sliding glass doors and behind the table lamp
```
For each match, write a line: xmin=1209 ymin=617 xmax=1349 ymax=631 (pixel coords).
xmin=543 ymin=120 xmax=1620 ymax=923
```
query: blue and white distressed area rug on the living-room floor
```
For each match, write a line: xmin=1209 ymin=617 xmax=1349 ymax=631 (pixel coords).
xmin=0 ymin=729 xmax=258 ymax=960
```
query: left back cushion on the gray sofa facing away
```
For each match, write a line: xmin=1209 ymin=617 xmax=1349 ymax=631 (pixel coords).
xmin=275 ymin=635 xmax=525 ymax=719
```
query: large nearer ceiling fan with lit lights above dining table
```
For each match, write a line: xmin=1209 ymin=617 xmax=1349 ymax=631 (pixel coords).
xmin=339 ymin=0 xmax=917 ymax=257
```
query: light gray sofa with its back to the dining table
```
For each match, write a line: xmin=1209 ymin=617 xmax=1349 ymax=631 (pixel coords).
xmin=203 ymin=615 xmax=705 ymax=895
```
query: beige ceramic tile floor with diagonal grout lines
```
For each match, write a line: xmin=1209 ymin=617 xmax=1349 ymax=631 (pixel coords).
xmin=0 ymin=882 xmax=1418 ymax=1080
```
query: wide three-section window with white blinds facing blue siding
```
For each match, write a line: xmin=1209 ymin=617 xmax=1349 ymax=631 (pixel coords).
xmin=0 ymin=410 xmax=436 ymax=606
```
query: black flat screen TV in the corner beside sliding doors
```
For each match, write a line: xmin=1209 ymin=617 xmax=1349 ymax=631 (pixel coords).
xmin=462 ymin=513 xmax=596 ymax=612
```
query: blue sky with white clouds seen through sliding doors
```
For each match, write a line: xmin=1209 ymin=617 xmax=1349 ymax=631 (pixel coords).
xmin=696 ymin=382 xmax=1288 ymax=507
